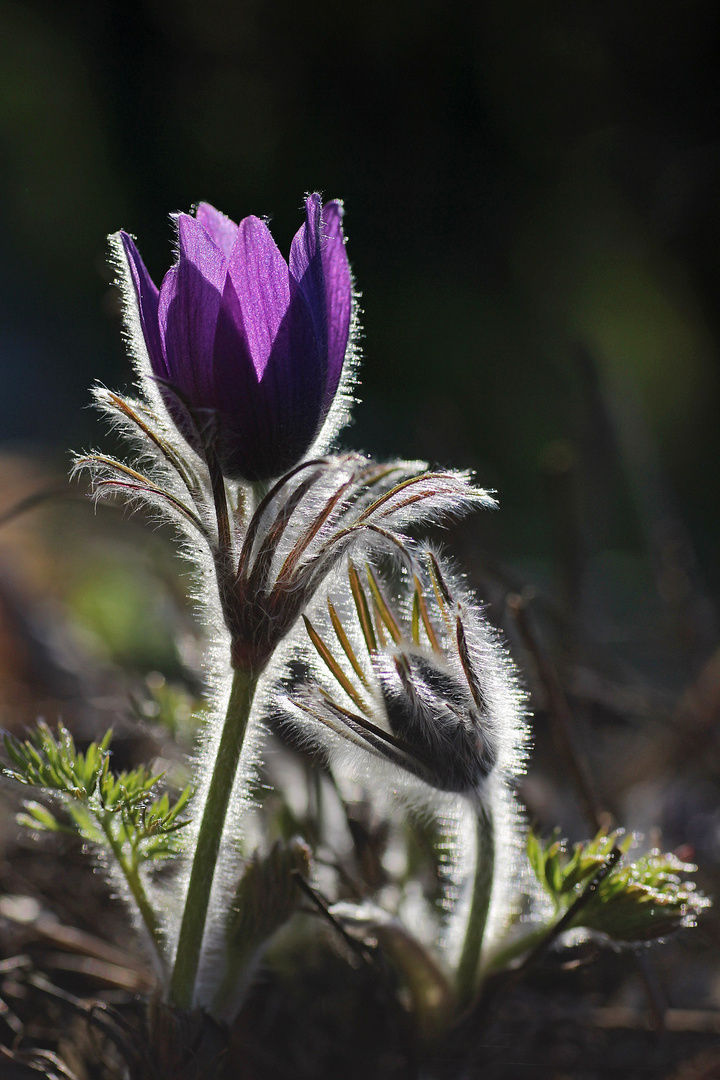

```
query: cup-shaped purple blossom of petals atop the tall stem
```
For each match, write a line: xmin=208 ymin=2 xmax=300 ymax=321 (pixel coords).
xmin=120 ymin=194 xmax=352 ymax=481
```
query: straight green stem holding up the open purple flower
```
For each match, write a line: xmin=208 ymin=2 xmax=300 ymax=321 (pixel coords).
xmin=169 ymin=669 xmax=258 ymax=1009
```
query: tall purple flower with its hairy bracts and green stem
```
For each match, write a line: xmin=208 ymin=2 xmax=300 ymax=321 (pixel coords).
xmin=76 ymin=194 xmax=500 ymax=1009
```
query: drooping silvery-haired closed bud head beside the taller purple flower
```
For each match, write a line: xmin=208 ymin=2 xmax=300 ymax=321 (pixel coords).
xmin=287 ymin=552 xmax=525 ymax=802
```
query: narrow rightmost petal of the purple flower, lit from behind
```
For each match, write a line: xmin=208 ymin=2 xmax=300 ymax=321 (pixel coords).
xmin=321 ymin=199 xmax=353 ymax=408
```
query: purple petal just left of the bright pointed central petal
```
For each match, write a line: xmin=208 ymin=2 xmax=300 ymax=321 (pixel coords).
xmin=158 ymin=214 xmax=228 ymax=407
